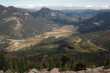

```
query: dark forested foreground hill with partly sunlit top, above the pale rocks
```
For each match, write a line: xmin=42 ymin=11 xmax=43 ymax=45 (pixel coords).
xmin=0 ymin=34 xmax=110 ymax=72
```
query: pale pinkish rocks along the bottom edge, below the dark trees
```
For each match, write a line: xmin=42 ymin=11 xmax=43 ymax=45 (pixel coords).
xmin=0 ymin=67 xmax=110 ymax=73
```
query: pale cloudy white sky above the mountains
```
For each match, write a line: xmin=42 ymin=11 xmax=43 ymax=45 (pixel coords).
xmin=0 ymin=0 xmax=110 ymax=8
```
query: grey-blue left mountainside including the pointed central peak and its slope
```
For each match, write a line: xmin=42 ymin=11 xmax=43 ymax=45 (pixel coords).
xmin=0 ymin=6 xmax=79 ymax=39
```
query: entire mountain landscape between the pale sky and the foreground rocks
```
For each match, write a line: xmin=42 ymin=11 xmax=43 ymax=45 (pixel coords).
xmin=0 ymin=5 xmax=110 ymax=73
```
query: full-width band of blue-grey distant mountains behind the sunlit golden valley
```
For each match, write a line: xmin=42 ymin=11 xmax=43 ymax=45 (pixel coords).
xmin=0 ymin=5 xmax=110 ymax=38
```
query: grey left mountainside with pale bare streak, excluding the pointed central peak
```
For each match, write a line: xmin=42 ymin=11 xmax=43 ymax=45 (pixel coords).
xmin=0 ymin=6 xmax=60 ymax=37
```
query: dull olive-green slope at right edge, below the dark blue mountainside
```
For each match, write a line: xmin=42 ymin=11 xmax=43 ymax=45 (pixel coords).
xmin=83 ymin=31 xmax=110 ymax=50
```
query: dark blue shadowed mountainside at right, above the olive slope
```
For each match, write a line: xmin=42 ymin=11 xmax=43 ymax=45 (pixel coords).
xmin=79 ymin=10 xmax=110 ymax=33
